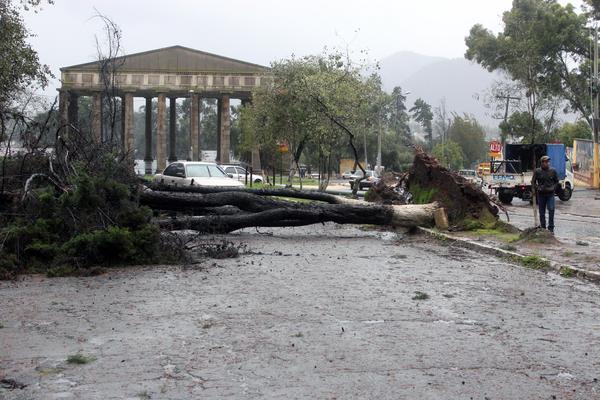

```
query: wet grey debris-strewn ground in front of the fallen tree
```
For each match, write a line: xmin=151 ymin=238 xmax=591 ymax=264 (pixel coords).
xmin=0 ymin=225 xmax=600 ymax=399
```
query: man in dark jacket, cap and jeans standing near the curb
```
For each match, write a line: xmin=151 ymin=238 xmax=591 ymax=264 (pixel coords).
xmin=531 ymin=156 xmax=558 ymax=233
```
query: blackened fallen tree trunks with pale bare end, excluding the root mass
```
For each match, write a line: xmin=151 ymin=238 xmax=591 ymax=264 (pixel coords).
xmin=140 ymin=191 xmax=438 ymax=233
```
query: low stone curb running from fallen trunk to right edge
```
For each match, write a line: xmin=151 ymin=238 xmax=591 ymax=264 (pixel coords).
xmin=417 ymin=227 xmax=600 ymax=283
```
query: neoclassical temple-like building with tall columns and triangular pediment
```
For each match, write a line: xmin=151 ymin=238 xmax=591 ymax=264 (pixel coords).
xmin=59 ymin=46 xmax=272 ymax=173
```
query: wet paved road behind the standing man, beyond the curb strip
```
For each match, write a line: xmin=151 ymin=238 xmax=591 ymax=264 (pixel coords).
xmin=503 ymin=189 xmax=600 ymax=244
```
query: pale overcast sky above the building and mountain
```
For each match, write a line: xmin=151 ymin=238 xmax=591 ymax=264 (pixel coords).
xmin=25 ymin=0 xmax=581 ymax=94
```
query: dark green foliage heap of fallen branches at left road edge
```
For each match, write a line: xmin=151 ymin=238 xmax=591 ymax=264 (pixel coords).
xmin=0 ymin=173 xmax=160 ymax=279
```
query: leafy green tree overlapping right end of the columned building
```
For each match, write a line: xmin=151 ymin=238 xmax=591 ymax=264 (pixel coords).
xmin=242 ymin=52 xmax=389 ymax=190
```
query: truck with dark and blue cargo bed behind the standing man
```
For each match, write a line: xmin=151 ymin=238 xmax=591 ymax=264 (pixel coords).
xmin=483 ymin=143 xmax=574 ymax=204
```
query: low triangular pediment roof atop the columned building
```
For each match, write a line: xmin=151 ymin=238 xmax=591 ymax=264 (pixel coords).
xmin=60 ymin=46 xmax=269 ymax=74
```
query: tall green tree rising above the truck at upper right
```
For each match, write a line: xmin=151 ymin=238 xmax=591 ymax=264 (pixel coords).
xmin=465 ymin=0 xmax=591 ymax=132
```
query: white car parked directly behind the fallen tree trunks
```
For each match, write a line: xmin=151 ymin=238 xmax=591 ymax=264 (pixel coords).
xmin=153 ymin=161 xmax=244 ymax=187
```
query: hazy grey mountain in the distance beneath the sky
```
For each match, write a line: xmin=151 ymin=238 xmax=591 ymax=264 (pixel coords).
xmin=380 ymin=52 xmax=500 ymax=127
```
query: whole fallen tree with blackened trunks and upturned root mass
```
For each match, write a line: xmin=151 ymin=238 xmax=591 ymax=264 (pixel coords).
xmin=139 ymin=149 xmax=498 ymax=233
